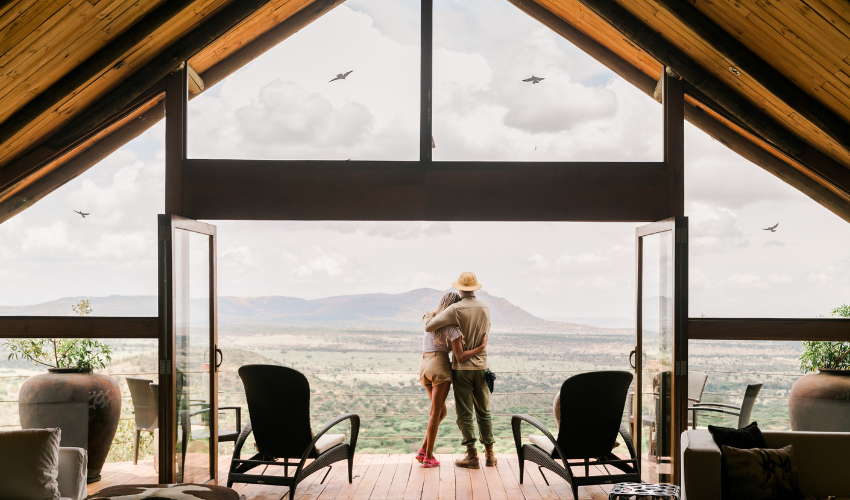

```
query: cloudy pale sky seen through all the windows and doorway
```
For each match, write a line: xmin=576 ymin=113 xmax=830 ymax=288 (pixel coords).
xmin=0 ymin=0 xmax=850 ymax=318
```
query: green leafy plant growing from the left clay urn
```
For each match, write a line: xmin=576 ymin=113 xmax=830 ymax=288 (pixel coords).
xmin=3 ymin=299 xmax=112 ymax=371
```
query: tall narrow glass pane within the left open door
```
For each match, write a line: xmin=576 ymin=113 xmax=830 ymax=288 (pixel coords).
xmin=174 ymin=229 xmax=212 ymax=483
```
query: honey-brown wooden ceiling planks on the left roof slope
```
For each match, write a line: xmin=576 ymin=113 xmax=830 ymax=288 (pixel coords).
xmin=0 ymin=0 xmax=322 ymax=205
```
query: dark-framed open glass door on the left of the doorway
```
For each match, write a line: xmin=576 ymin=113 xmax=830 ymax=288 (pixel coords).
xmin=159 ymin=215 xmax=221 ymax=484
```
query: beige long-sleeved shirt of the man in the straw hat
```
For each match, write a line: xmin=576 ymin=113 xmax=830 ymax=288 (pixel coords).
xmin=422 ymin=296 xmax=490 ymax=370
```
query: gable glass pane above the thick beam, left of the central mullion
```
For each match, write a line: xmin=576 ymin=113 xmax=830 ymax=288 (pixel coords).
xmin=188 ymin=0 xmax=420 ymax=161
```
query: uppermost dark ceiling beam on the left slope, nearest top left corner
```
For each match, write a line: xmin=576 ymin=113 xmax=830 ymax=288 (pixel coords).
xmin=0 ymin=0 xmax=196 ymax=150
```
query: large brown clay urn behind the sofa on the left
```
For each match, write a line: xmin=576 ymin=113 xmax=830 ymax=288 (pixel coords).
xmin=18 ymin=368 xmax=121 ymax=483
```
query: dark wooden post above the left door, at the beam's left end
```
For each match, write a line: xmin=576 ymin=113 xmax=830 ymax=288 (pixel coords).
xmin=165 ymin=63 xmax=189 ymax=215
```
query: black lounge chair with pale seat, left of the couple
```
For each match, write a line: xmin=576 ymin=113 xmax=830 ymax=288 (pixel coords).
xmin=227 ymin=365 xmax=360 ymax=500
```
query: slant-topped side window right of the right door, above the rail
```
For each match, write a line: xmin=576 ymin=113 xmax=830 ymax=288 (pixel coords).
xmin=685 ymin=123 xmax=850 ymax=318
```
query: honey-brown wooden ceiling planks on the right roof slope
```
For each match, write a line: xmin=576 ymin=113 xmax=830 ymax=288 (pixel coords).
xmin=532 ymin=0 xmax=850 ymax=211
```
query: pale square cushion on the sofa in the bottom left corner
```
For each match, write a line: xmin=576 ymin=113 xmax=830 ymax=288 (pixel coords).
xmin=0 ymin=428 xmax=62 ymax=500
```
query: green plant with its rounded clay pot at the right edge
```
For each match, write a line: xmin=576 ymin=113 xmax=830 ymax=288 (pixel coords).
xmin=788 ymin=304 xmax=850 ymax=432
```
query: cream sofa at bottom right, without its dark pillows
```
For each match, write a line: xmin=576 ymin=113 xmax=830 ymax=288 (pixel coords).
xmin=681 ymin=429 xmax=850 ymax=500
